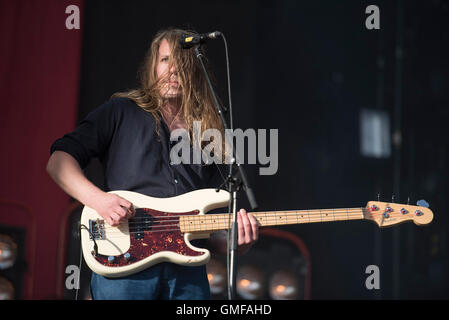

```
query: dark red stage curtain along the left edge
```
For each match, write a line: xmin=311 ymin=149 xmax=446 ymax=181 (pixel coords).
xmin=0 ymin=0 xmax=84 ymax=299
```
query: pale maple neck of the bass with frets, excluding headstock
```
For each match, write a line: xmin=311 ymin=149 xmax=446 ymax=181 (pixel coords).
xmin=179 ymin=208 xmax=364 ymax=232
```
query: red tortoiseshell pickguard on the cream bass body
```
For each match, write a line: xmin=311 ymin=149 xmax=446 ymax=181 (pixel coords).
xmin=92 ymin=208 xmax=204 ymax=267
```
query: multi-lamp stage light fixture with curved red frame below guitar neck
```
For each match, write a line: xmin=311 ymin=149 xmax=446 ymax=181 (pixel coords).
xmin=206 ymin=228 xmax=311 ymax=300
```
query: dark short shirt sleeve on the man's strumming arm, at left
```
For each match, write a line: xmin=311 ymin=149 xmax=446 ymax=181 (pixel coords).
xmin=50 ymin=100 xmax=117 ymax=168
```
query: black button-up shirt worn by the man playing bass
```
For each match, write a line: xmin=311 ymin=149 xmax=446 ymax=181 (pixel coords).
xmin=50 ymin=98 xmax=219 ymax=198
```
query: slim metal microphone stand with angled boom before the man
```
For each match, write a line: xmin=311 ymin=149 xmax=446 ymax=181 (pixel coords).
xmin=195 ymin=44 xmax=257 ymax=300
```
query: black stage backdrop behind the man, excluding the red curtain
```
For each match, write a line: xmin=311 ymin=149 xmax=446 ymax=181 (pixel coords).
xmin=78 ymin=0 xmax=449 ymax=299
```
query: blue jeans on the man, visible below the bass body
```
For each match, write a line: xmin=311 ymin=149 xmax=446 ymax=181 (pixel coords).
xmin=90 ymin=262 xmax=210 ymax=300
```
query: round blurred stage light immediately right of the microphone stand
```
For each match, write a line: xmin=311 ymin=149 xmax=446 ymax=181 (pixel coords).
xmin=236 ymin=265 xmax=265 ymax=300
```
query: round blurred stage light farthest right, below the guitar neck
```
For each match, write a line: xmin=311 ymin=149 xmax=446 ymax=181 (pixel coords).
xmin=269 ymin=270 xmax=299 ymax=300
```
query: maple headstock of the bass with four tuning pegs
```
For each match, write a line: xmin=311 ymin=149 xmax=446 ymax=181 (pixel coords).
xmin=364 ymin=201 xmax=433 ymax=227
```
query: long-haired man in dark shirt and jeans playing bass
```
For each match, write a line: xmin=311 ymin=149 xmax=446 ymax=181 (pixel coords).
xmin=47 ymin=29 xmax=258 ymax=299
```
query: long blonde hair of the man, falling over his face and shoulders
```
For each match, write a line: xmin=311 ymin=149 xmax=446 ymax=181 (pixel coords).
xmin=112 ymin=28 xmax=225 ymax=159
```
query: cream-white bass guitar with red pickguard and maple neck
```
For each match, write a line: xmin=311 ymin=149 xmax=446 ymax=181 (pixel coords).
xmin=81 ymin=189 xmax=433 ymax=278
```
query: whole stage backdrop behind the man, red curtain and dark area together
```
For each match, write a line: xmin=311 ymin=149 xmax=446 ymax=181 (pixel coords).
xmin=0 ymin=0 xmax=449 ymax=300
